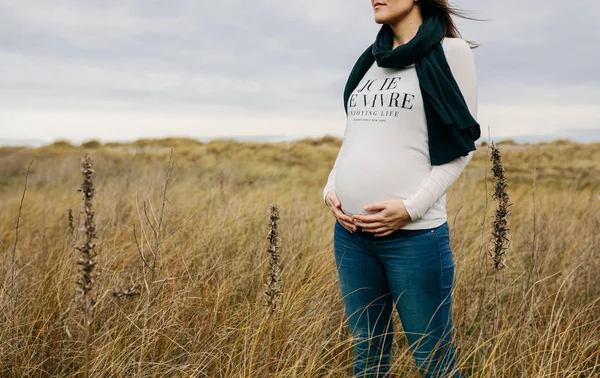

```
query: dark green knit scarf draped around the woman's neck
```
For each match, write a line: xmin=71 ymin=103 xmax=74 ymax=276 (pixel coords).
xmin=344 ymin=16 xmax=481 ymax=165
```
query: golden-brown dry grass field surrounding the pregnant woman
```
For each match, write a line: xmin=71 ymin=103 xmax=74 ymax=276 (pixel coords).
xmin=0 ymin=137 xmax=600 ymax=378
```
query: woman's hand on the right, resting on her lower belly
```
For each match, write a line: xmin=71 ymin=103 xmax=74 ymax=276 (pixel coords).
xmin=352 ymin=198 xmax=411 ymax=236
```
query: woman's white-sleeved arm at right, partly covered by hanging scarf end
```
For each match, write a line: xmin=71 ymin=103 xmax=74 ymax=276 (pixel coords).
xmin=403 ymin=38 xmax=478 ymax=221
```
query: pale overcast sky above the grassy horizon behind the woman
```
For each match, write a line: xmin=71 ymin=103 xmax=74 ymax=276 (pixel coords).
xmin=0 ymin=0 xmax=600 ymax=142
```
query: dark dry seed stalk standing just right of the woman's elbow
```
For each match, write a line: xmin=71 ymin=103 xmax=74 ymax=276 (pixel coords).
xmin=490 ymin=142 xmax=512 ymax=334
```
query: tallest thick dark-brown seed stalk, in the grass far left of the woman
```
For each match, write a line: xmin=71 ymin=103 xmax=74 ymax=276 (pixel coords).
xmin=75 ymin=154 xmax=97 ymax=378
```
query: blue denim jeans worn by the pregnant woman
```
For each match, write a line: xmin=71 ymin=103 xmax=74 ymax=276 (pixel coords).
xmin=333 ymin=221 xmax=461 ymax=378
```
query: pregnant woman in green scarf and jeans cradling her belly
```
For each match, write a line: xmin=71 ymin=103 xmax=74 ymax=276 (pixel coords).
xmin=323 ymin=0 xmax=480 ymax=377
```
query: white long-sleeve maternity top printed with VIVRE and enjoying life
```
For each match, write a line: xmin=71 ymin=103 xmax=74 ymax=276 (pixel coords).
xmin=323 ymin=38 xmax=477 ymax=229
